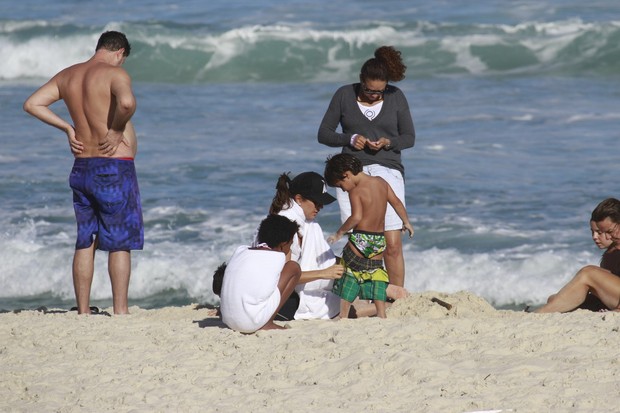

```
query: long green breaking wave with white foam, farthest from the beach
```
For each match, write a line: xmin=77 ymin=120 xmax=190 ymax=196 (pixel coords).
xmin=0 ymin=19 xmax=618 ymax=81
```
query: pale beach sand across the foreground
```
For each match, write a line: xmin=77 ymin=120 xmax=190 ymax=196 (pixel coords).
xmin=0 ymin=292 xmax=620 ymax=412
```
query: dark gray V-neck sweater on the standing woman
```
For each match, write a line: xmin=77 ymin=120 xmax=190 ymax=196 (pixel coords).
xmin=318 ymin=83 xmax=415 ymax=176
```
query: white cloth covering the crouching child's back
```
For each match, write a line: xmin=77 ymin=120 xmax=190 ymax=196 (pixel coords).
xmin=220 ymin=245 xmax=286 ymax=333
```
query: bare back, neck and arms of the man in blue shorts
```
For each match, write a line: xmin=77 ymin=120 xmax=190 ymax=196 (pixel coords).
xmin=24 ymin=43 xmax=137 ymax=158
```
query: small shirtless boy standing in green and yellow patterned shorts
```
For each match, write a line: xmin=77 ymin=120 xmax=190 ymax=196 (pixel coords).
xmin=324 ymin=153 xmax=413 ymax=318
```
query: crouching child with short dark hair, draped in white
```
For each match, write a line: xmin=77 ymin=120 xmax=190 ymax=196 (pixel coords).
xmin=220 ymin=215 xmax=301 ymax=333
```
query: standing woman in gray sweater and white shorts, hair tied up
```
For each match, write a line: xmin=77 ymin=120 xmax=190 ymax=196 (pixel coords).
xmin=318 ymin=46 xmax=415 ymax=287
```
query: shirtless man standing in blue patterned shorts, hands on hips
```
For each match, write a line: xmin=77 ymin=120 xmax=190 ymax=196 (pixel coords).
xmin=24 ymin=31 xmax=144 ymax=314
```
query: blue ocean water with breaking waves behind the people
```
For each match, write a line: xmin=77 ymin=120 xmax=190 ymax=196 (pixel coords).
xmin=0 ymin=0 xmax=620 ymax=309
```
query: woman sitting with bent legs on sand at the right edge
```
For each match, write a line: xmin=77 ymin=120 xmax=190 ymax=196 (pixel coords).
xmin=535 ymin=198 xmax=620 ymax=313
